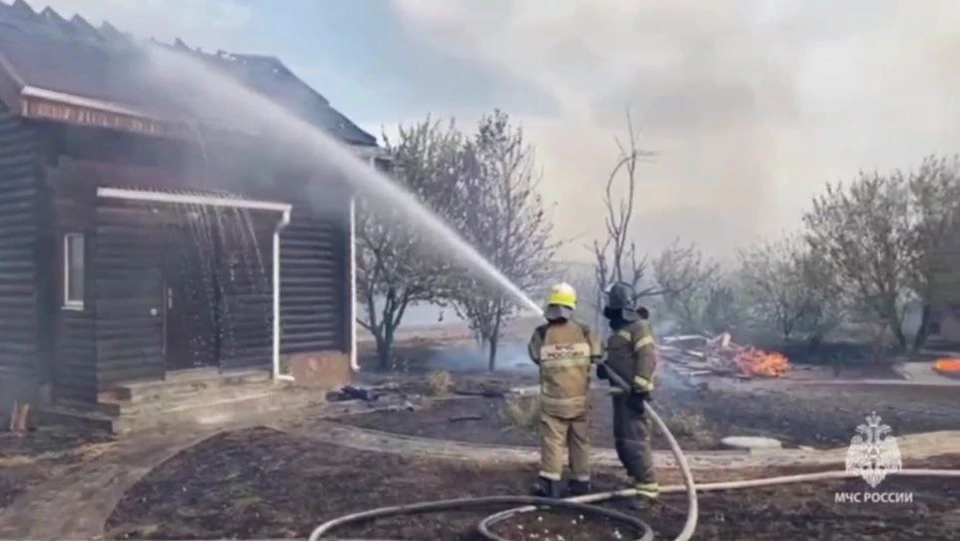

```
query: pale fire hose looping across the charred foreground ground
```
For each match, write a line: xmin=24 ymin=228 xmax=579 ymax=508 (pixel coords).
xmin=308 ymin=358 xmax=960 ymax=541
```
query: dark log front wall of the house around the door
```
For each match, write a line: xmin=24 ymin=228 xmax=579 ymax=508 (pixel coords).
xmin=26 ymin=120 xmax=353 ymax=403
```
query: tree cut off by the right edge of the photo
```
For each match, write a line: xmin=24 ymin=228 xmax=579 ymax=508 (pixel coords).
xmin=896 ymin=156 xmax=960 ymax=350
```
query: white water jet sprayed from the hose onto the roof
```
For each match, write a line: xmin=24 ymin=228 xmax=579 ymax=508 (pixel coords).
xmin=132 ymin=46 xmax=540 ymax=311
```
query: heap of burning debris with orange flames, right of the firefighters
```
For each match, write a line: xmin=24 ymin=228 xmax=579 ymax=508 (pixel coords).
xmin=662 ymin=333 xmax=790 ymax=379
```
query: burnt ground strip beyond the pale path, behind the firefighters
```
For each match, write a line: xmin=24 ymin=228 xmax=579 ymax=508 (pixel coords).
xmin=338 ymin=380 xmax=960 ymax=450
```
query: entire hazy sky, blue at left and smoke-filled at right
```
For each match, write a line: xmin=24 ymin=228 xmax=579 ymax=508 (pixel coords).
xmin=31 ymin=0 xmax=960 ymax=259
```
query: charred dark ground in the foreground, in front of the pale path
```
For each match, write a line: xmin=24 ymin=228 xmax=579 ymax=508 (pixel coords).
xmin=107 ymin=428 xmax=960 ymax=541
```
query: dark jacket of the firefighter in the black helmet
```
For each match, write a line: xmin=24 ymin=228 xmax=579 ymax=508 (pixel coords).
xmin=606 ymin=320 xmax=657 ymax=392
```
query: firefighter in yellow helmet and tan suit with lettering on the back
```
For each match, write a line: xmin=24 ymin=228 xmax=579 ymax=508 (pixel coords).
xmin=529 ymin=283 xmax=602 ymax=498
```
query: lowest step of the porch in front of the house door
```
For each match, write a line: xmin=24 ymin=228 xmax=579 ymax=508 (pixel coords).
xmin=112 ymin=387 xmax=325 ymax=434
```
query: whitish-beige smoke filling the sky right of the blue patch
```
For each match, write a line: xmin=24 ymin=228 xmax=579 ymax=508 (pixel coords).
xmin=394 ymin=0 xmax=960 ymax=259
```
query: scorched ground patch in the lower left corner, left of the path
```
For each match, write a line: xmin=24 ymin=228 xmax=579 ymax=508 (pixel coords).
xmin=0 ymin=429 xmax=110 ymax=509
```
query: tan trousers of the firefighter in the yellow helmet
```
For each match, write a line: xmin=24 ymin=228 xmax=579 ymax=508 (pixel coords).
xmin=540 ymin=413 xmax=590 ymax=481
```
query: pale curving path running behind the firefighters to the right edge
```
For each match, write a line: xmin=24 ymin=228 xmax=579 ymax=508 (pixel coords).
xmin=272 ymin=421 xmax=960 ymax=470
